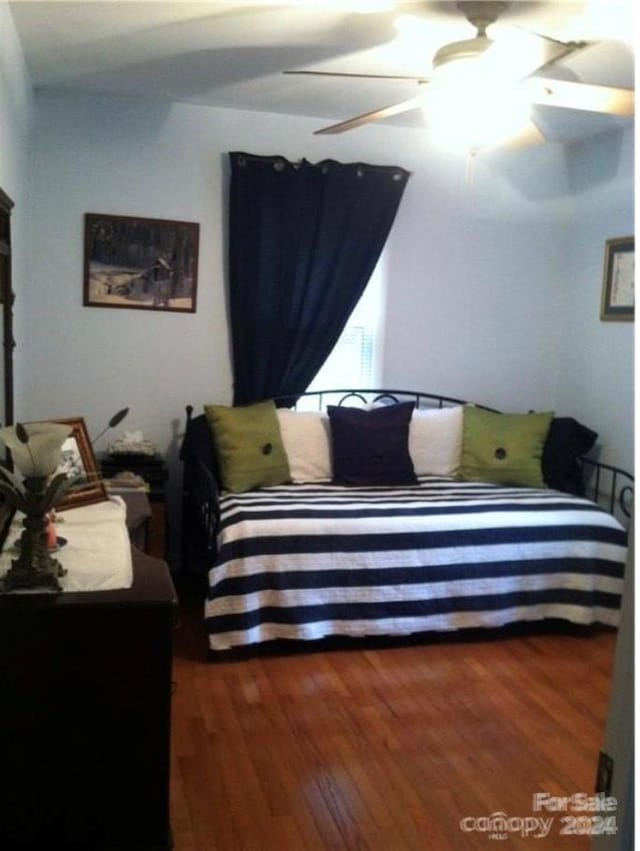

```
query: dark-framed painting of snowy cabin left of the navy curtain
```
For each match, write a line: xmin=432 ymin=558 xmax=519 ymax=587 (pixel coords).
xmin=83 ymin=213 xmax=200 ymax=313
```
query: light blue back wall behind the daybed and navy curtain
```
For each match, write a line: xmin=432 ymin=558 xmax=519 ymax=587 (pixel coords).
xmin=18 ymin=85 xmax=632 ymax=544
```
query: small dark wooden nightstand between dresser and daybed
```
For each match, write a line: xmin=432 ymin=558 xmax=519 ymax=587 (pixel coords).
xmin=100 ymin=454 xmax=169 ymax=558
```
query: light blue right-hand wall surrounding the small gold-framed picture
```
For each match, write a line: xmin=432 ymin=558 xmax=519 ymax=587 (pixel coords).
xmin=557 ymin=131 xmax=635 ymax=469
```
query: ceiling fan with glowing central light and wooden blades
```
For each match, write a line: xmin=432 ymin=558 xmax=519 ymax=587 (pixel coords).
xmin=298 ymin=0 xmax=634 ymax=140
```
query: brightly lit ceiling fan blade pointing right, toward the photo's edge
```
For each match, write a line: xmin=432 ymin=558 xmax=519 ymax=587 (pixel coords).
xmin=521 ymin=77 xmax=635 ymax=116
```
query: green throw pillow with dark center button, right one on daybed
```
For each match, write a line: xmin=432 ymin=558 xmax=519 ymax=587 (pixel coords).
xmin=459 ymin=405 xmax=553 ymax=488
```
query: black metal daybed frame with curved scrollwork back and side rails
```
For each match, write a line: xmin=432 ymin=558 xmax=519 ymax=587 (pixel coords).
xmin=180 ymin=389 xmax=634 ymax=570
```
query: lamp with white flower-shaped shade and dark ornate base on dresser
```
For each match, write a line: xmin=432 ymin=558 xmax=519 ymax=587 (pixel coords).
xmin=0 ymin=422 xmax=72 ymax=591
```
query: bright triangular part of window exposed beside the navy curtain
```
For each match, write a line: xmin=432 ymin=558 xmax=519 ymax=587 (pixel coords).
xmin=307 ymin=255 xmax=384 ymax=390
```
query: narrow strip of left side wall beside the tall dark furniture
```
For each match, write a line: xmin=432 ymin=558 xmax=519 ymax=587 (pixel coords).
xmin=0 ymin=0 xmax=32 ymax=422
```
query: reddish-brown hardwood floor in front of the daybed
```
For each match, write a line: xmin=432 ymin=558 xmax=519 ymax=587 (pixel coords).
xmin=171 ymin=587 xmax=615 ymax=851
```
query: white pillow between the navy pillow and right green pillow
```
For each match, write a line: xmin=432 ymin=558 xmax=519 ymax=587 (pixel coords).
xmin=409 ymin=405 xmax=463 ymax=476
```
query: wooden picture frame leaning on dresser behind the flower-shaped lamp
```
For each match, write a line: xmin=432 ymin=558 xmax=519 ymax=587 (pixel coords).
xmin=52 ymin=417 xmax=108 ymax=511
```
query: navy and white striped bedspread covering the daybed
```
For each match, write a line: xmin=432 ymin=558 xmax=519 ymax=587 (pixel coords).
xmin=205 ymin=477 xmax=626 ymax=650
